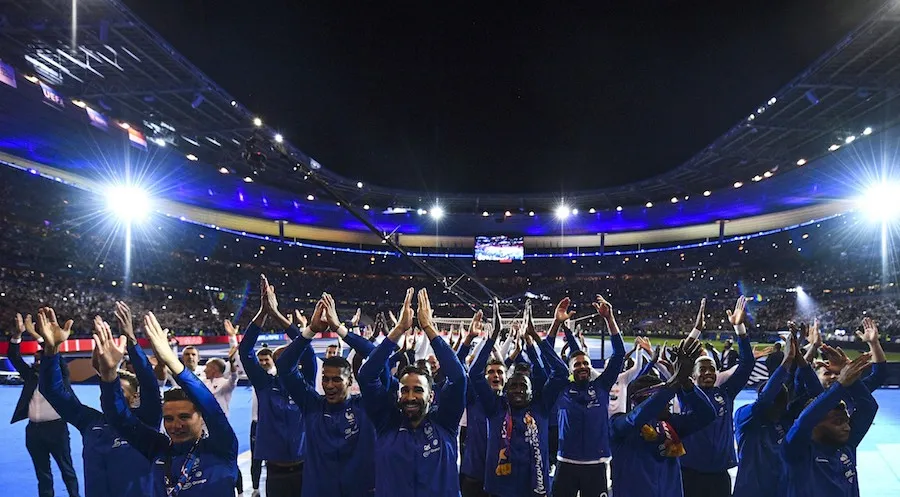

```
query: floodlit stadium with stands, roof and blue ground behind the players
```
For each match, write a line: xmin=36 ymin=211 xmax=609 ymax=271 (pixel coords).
xmin=0 ymin=0 xmax=900 ymax=497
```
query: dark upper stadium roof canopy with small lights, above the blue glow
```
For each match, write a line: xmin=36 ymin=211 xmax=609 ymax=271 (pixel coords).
xmin=0 ymin=0 xmax=900 ymax=212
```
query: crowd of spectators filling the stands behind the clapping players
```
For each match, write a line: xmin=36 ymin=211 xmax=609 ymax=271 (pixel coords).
xmin=0 ymin=168 xmax=900 ymax=337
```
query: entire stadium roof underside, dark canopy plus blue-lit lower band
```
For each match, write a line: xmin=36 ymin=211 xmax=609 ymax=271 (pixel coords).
xmin=0 ymin=0 xmax=900 ymax=235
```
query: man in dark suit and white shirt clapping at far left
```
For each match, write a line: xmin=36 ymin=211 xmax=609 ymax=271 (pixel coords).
xmin=7 ymin=314 xmax=79 ymax=497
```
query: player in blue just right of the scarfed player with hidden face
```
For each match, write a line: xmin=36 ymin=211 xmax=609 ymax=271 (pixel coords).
xmin=681 ymin=297 xmax=755 ymax=497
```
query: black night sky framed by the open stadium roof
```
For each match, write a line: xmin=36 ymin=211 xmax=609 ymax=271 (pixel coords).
xmin=125 ymin=0 xmax=881 ymax=193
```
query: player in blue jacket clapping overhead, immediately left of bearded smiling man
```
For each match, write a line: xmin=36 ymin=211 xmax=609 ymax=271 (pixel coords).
xmin=276 ymin=294 xmax=375 ymax=497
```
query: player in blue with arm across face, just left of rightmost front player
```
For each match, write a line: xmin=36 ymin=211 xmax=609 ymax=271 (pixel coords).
xmin=733 ymin=335 xmax=822 ymax=497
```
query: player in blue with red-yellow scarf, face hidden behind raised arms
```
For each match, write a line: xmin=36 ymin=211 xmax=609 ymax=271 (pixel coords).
xmin=609 ymin=341 xmax=716 ymax=497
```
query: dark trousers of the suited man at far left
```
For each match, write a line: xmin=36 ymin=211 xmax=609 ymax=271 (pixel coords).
xmin=25 ymin=419 xmax=79 ymax=497
